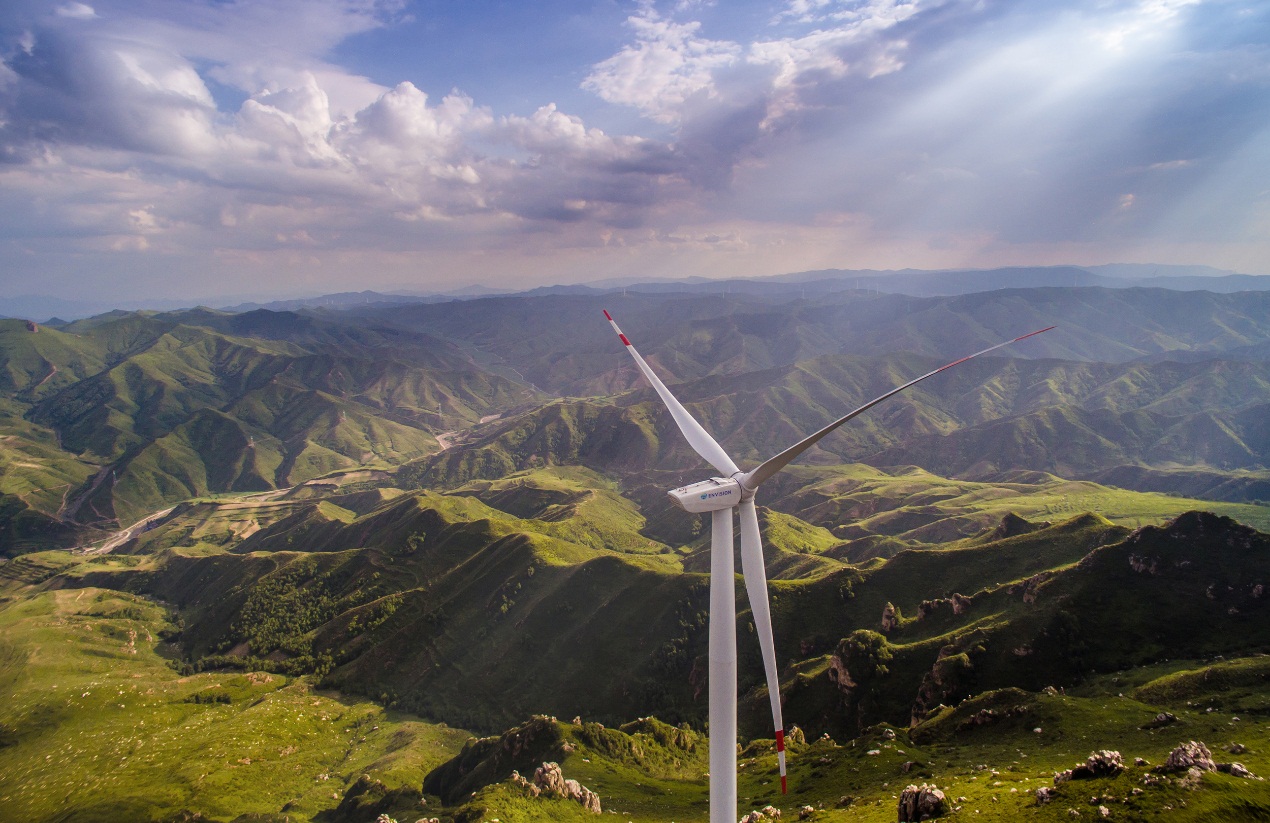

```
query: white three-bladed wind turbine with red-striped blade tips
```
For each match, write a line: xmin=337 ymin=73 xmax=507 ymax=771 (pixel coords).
xmin=605 ymin=310 xmax=1054 ymax=823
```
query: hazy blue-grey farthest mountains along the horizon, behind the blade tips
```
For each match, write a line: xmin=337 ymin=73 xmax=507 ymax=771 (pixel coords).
xmin=354 ymin=288 xmax=1270 ymax=396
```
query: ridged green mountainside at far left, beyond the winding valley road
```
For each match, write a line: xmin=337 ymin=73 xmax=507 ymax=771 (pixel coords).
xmin=0 ymin=309 xmax=537 ymax=552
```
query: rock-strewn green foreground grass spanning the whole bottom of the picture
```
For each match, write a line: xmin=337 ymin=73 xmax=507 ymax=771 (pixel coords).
xmin=0 ymin=579 xmax=1270 ymax=823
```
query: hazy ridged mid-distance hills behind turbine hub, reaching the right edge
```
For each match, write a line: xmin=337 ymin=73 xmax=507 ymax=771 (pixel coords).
xmin=403 ymin=347 xmax=1270 ymax=500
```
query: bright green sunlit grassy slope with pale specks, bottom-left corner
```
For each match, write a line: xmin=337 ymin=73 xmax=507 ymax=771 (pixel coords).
xmin=0 ymin=588 xmax=465 ymax=823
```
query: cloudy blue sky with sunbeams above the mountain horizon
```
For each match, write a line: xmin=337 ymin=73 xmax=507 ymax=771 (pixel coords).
xmin=0 ymin=0 xmax=1270 ymax=300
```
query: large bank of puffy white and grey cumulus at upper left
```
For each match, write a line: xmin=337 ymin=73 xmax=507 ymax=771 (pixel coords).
xmin=0 ymin=3 xmax=701 ymax=276
